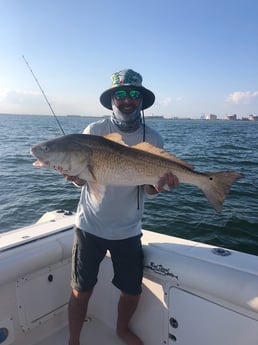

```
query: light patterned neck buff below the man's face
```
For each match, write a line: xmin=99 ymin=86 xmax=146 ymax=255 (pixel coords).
xmin=111 ymin=99 xmax=142 ymax=132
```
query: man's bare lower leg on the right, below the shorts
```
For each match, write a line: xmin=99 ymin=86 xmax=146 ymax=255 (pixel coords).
xmin=116 ymin=292 xmax=144 ymax=345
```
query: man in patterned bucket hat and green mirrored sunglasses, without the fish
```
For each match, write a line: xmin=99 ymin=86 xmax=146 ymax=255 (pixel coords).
xmin=66 ymin=69 xmax=178 ymax=345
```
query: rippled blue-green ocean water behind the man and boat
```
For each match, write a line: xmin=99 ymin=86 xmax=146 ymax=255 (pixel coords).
xmin=0 ymin=115 xmax=258 ymax=255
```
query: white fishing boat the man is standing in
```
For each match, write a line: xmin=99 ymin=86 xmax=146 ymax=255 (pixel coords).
xmin=0 ymin=211 xmax=258 ymax=345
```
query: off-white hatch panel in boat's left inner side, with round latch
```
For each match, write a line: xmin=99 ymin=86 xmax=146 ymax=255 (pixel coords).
xmin=16 ymin=261 xmax=71 ymax=332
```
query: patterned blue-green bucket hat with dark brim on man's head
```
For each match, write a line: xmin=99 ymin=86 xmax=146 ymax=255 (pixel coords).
xmin=100 ymin=69 xmax=155 ymax=110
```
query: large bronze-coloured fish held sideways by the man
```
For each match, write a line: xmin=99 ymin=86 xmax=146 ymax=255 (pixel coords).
xmin=30 ymin=133 xmax=244 ymax=213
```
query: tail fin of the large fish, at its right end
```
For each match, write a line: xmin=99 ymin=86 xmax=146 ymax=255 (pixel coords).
xmin=199 ymin=171 xmax=244 ymax=213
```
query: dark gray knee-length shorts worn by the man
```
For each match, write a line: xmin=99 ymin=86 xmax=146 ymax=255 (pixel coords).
xmin=71 ymin=227 xmax=143 ymax=295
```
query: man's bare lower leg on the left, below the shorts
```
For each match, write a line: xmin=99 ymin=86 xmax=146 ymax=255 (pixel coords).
xmin=68 ymin=290 xmax=92 ymax=345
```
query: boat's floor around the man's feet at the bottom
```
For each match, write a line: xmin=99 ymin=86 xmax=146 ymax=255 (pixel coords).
xmin=35 ymin=318 xmax=124 ymax=345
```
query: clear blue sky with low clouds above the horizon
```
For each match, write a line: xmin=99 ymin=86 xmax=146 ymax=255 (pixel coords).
xmin=0 ymin=0 xmax=258 ymax=118
